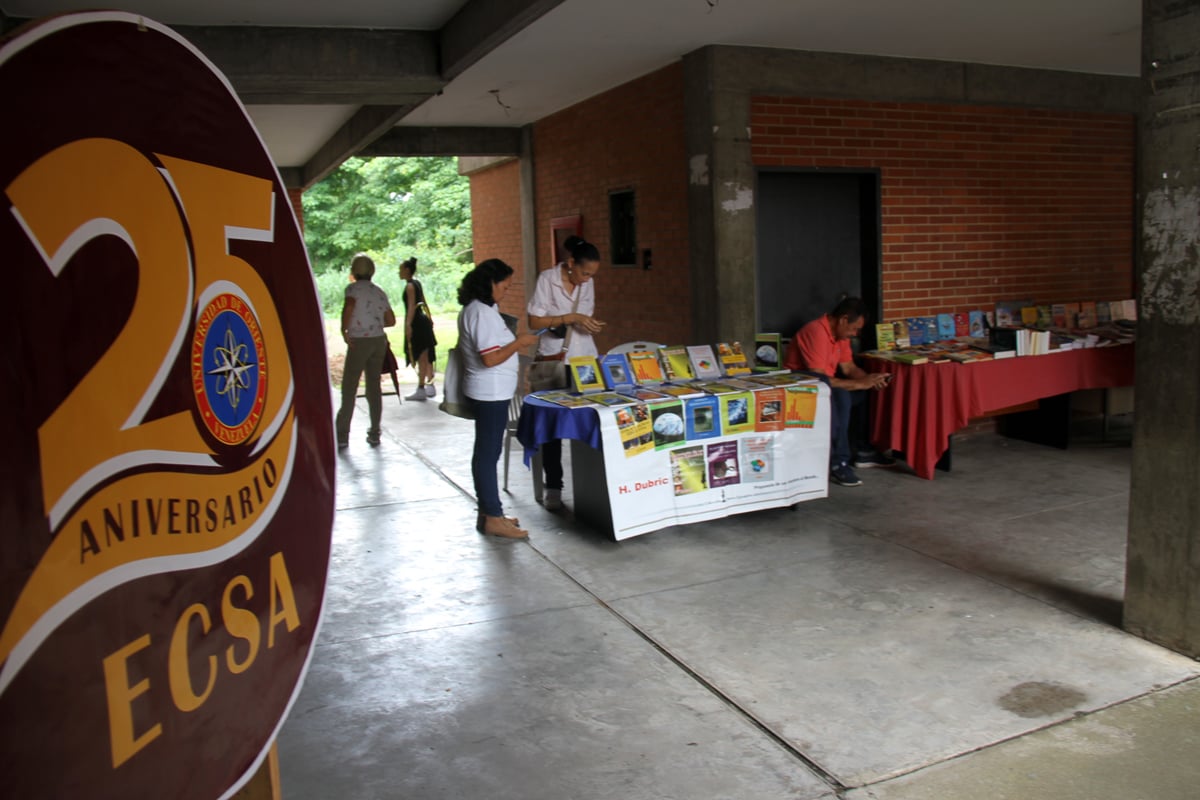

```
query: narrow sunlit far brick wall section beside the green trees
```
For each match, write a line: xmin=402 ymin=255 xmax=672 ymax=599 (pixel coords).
xmin=470 ymin=155 xmax=526 ymax=319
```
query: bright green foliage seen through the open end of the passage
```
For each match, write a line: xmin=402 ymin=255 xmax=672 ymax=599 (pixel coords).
xmin=304 ymin=158 xmax=473 ymax=316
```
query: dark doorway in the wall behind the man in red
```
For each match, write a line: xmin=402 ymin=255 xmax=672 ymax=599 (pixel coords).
xmin=756 ymin=170 xmax=881 ymax=348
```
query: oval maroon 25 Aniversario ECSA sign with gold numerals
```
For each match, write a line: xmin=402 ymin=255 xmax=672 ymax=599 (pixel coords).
xmin=0 ymin=12 xmax=334 ymax=798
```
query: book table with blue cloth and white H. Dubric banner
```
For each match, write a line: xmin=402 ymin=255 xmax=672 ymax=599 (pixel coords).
xmin=517 ymin=336 xmax=830 ymax=540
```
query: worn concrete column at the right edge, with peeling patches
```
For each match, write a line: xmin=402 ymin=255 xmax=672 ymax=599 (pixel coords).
xmin=1124 ymin=0 xmax=1200 ymax=657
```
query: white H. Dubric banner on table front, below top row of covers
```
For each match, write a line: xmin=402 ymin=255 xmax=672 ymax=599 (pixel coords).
xmin=596 ymin=384 xmax=830 ymax=540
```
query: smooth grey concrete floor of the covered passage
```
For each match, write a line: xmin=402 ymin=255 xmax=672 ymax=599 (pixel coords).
xmin=280 ymin=387 xmax=1200 ymax=800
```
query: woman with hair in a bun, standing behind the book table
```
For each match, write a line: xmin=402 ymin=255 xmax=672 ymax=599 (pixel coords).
xmin=526 ymin=236 xmax=604 ymax=511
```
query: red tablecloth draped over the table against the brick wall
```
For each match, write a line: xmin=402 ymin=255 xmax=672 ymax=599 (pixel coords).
xmin=865 ymin=344 xmax=1133 ymax=479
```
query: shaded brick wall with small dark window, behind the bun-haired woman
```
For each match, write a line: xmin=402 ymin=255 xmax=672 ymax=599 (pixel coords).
xmin=533 ymin=64 xmax=691 ymax=353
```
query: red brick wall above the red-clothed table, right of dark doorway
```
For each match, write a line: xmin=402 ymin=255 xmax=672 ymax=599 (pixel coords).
xmin=751 ymin=97 xmax=1135 ymax=320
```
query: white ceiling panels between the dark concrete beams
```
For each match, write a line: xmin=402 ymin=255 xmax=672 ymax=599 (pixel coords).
xmin=0 ymin=0 xmax=1141 ymax=167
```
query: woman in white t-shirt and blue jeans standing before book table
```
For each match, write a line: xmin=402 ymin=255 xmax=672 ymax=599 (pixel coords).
xmin=458 ymin=258 xmax=538 ymax=539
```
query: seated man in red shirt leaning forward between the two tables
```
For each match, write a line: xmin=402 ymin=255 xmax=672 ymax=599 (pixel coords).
xmin=784 ymin=297 xmax=895 ymax=486
